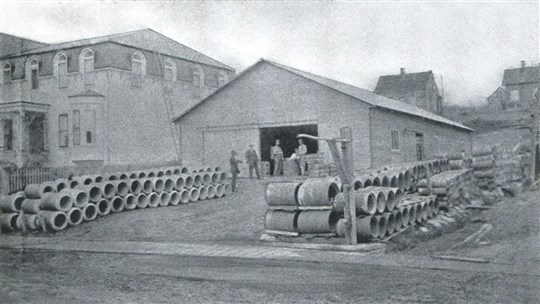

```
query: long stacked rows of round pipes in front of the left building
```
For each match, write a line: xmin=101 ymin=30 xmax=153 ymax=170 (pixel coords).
xmin=0 ymin=167 xmax=231 ymax=232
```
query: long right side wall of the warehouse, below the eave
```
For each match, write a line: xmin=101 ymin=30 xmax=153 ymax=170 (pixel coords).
xmin=371 ymin=108 xmax=472 ymax=168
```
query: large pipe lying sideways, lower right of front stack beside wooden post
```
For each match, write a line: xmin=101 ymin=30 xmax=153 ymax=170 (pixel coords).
xmin=297 ymin=210 xmax=339 ymax=234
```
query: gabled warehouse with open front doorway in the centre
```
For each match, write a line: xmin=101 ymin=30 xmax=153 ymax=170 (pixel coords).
xmin=174 ymin=59 xmax=473 ymax=173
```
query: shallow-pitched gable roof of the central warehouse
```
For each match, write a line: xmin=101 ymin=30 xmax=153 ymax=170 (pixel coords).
xmin=173 ymin=59 xmax=474 ymax=131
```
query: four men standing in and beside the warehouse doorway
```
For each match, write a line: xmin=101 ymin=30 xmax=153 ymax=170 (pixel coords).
xmin=229 ymin=139 xmax=307 ymax=192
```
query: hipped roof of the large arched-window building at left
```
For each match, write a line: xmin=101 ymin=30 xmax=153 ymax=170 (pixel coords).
xmin=2 ymin=29 xmax=234 ymax=71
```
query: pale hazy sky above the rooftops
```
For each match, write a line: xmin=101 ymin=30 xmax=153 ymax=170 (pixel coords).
xmin=0 ymin=0 xmax=540 ymax=105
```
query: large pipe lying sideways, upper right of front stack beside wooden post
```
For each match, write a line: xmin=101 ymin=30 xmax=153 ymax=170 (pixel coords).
xmin=298 ymin=178 xmax=340 ymax=206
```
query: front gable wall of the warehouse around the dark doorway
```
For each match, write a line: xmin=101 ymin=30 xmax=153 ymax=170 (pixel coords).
xmin=177 ymin=62 xmax=376 ymax=168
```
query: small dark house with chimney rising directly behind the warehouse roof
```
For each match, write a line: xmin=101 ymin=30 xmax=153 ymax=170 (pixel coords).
xmin=374 ymin=68 xmax=443 ymax=115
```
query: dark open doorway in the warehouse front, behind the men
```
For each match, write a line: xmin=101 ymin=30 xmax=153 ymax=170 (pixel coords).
xmin=260 ymin=125 xmax=319 ymax=176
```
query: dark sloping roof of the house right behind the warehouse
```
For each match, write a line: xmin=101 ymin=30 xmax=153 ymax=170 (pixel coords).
xmin=374 ymin=71 xmax=433 ymax=99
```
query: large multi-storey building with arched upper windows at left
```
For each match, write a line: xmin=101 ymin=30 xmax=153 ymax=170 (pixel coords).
xmin=0 ymin=29 xmax=235 ymax=167
